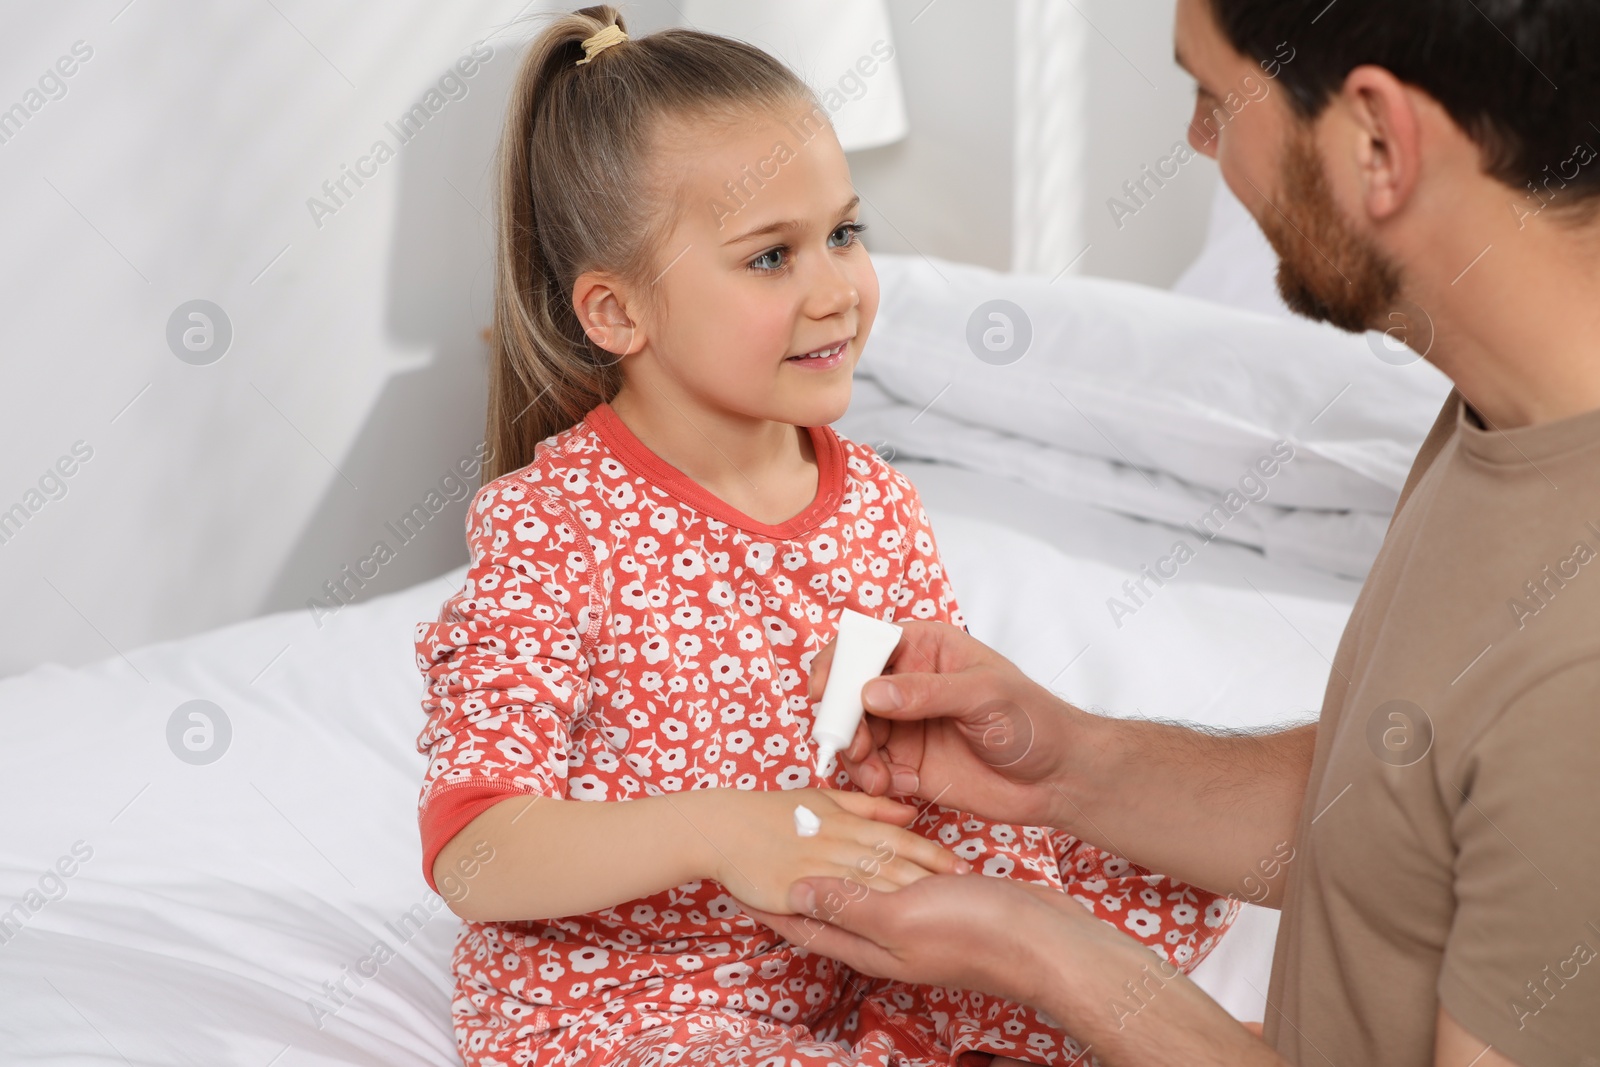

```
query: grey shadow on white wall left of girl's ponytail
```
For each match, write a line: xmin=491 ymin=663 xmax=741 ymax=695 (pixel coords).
xmin=259 ymin=38 xmax=522 ymax=621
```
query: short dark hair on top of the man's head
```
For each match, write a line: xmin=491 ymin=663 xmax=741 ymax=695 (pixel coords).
xmin=1211 ymin=0 xmax=1600 ymax=205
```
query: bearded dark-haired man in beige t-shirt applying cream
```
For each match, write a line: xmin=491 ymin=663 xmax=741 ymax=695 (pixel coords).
xmin=763 ymin=0 xmax=1600 ymax=1067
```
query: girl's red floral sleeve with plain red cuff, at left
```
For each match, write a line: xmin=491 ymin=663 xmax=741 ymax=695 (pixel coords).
xmin=416 ymin=480 xmax=598 ymax=893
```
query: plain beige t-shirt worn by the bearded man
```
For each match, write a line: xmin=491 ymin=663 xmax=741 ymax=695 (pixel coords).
xmin=1266 ymin=394 xmax=1600 ymax=1067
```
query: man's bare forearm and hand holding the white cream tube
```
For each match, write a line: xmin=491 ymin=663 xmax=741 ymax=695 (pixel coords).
xmin=811 ymin=622 xmax=1315 ymax=905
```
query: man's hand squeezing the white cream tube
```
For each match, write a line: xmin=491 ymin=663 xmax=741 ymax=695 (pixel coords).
xmin=811 ymin=622 xmax=1090 ymax=825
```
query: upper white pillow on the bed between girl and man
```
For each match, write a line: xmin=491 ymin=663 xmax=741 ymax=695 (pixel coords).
xmin=859 ymin=254 xmax=1450 ymax=512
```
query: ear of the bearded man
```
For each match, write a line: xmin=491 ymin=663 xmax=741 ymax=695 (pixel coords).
xmin=1341 ymin=64 xmax=1422 ymax=221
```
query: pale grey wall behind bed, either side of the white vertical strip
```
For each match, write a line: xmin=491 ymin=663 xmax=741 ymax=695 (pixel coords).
xmin=851 ymin=0 xmax=1218 ymax=288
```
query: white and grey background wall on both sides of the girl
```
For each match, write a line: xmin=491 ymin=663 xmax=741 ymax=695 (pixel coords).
xmin=0 ymin=0 xmax=1214 ymax=673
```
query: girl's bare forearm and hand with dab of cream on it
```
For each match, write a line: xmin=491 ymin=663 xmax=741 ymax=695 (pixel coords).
xmin=434 ymin=789 xmax=970 ymax=921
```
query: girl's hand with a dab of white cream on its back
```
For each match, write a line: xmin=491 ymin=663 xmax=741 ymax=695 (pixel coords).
xmin=674 ymin=789 xmax=971 ymax=913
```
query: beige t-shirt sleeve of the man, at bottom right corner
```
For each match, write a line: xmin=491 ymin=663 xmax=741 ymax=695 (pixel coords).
xmin=1438 ymin=657 xmax=1600 ymax=1064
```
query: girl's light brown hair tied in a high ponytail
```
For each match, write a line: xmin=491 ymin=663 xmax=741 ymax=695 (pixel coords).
xmin=483 ymin=5 xmax=826 ymax=483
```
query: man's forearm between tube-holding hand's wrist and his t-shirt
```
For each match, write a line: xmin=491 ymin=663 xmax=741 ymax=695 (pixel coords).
xmin=1054 ymin=709 xmax=1317 ymax=907
